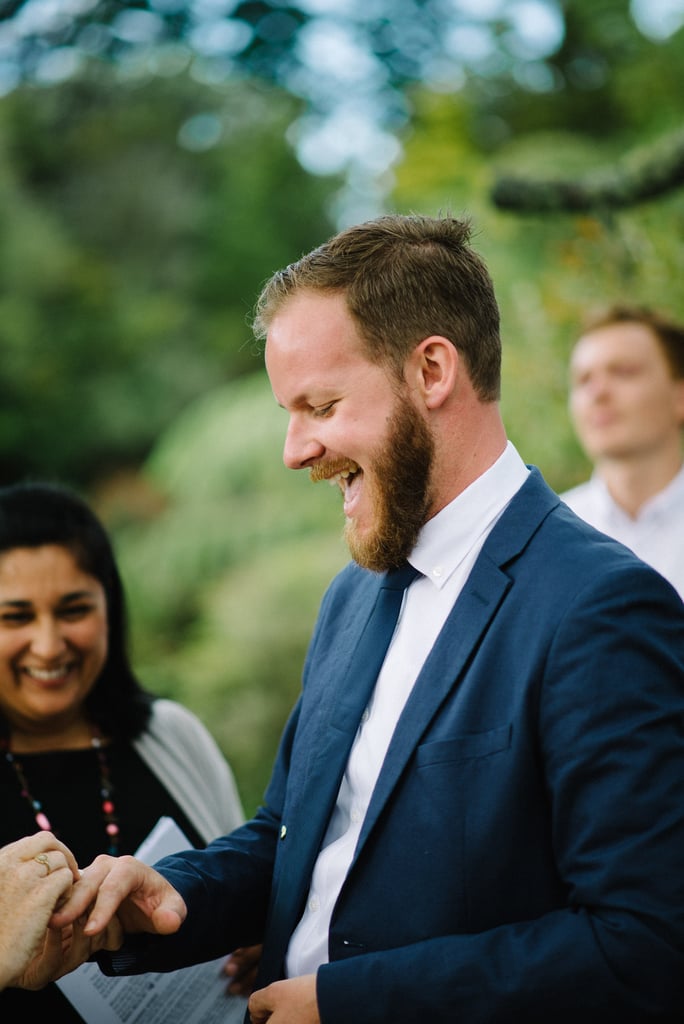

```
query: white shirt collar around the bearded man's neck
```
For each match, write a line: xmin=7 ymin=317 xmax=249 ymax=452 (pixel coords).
xmin=409 ymin=441 xmax=529 ymax=587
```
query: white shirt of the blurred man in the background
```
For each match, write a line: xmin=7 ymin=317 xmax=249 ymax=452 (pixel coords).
xmin=560 ymin=466 xmax=684 ymax=599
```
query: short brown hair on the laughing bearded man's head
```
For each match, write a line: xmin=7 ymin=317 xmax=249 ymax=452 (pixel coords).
xmin=253 ymin=214 xmax=501 ymax=401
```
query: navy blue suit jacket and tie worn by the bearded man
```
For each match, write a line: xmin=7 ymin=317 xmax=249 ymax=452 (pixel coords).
xmin=100 ymin=470 xmax=684 ymax=1024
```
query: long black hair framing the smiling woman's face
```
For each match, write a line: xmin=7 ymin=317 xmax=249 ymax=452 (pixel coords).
xmin=0 ymin=481 xmax=154 ymax=739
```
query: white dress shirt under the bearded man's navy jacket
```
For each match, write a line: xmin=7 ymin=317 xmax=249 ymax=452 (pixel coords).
xmin=286 ymin=441 xmax=529 ymax=977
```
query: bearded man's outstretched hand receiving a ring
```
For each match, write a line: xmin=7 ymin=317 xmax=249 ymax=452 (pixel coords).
xmin=50 ymin=854 xmax=187 ymax=948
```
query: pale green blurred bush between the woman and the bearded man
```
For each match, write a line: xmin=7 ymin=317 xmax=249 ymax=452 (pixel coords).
xmin=111 ymin=372 xmax=348 ymax=809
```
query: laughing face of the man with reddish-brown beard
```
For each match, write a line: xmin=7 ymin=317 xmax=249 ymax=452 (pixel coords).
xmin=266 ymin=292 xmax=433 ymax=571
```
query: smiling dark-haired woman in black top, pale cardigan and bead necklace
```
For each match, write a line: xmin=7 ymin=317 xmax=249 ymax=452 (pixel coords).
xmin=0 ymin=482 xmax=250 ymax=1024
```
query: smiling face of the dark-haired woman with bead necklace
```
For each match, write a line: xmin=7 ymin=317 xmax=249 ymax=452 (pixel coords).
xmin=0 ymin=544 xmax=108 ymax=731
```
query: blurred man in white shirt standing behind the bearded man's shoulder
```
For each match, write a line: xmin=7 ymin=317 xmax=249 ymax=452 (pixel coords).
xmin=561 ymin=306 xmax=684 ymax=597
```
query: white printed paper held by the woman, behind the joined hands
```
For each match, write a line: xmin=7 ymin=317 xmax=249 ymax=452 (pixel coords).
xmin=57 ymin=817 xmax=247 ymax=1024
